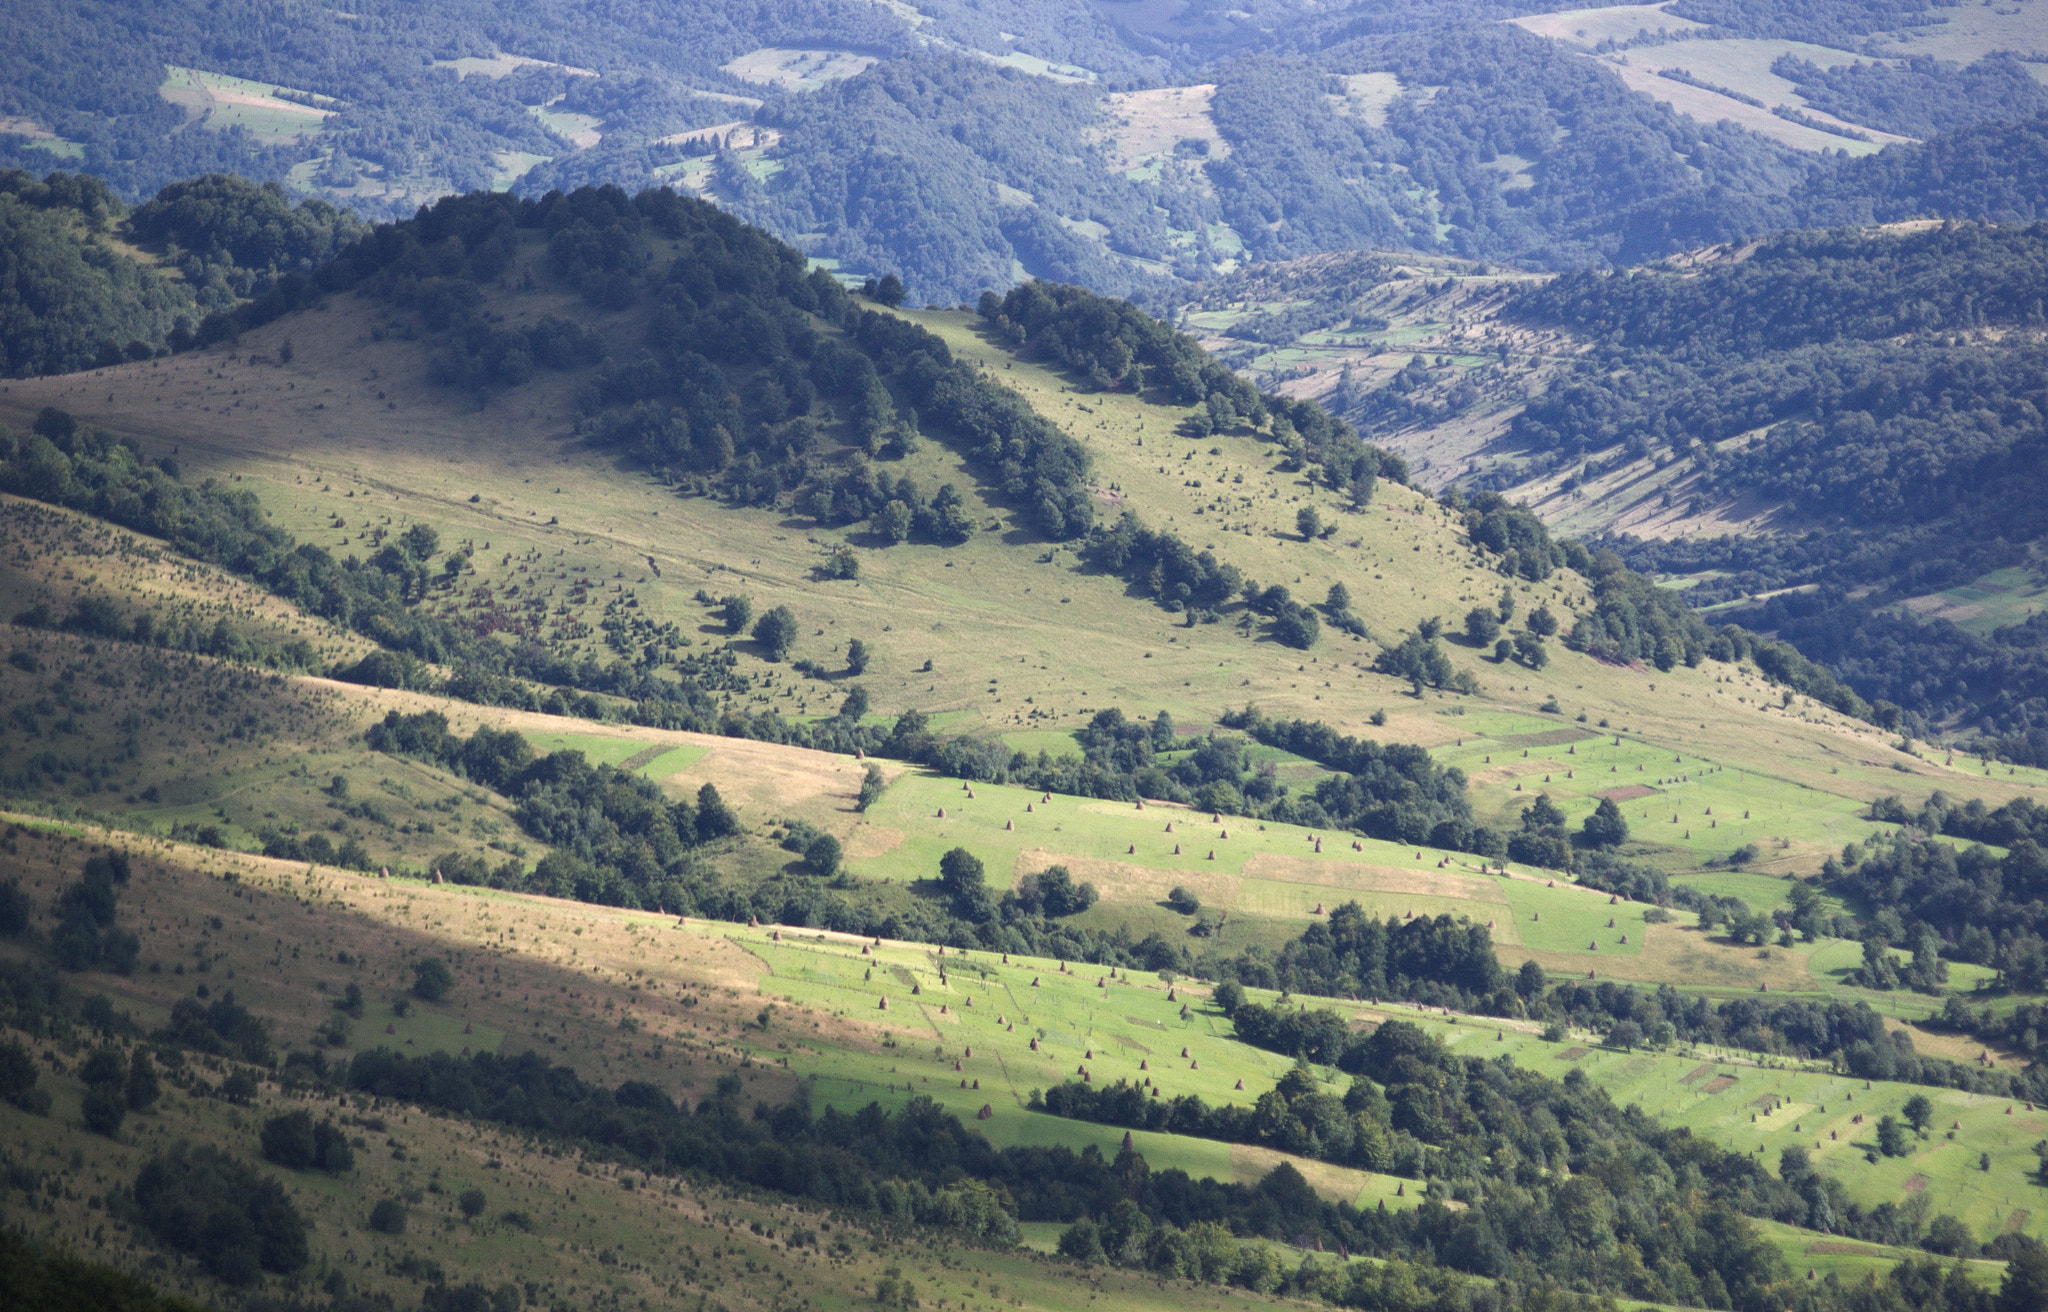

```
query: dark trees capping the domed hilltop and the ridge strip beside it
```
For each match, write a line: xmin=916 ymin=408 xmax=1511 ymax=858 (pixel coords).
xmin=184 ymin=186 xmax=1407 ymax=556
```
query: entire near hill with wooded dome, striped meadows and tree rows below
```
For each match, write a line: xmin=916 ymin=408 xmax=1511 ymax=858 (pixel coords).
xmin=0 ymin=190 xmax=2048 ymax=1308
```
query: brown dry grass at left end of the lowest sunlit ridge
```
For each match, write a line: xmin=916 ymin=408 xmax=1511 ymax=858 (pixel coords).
xmin=8 ymin=817 xmax=794 ymax=1099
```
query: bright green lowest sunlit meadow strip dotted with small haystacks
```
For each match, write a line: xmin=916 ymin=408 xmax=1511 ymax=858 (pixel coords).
xmin=690 ymin=923 xmax=2048 ymax=1242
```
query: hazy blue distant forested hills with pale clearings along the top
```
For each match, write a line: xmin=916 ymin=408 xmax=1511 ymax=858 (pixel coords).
xmin=12 ymin=0 xmax=2044 ymax=303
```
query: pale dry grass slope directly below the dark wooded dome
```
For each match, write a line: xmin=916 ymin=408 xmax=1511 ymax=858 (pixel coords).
xmin=8 ymin=278 xmax=1990 ymax=839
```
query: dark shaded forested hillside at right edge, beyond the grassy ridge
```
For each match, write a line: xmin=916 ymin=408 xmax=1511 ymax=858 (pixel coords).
xmin=1507 ymin=223 xmax=2048 ymax=759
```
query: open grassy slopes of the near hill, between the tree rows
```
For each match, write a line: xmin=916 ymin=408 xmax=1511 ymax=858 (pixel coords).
xmin=0 ymin=220 xmax=2048 ymax=1312
